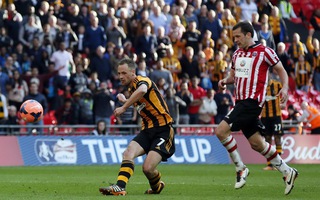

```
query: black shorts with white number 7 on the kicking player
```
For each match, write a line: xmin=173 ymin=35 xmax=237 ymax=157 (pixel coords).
xmin=133 ymin=125 xmax=175 ymax=161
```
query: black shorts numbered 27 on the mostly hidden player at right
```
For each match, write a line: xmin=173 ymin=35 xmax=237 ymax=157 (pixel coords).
xmin=261 ymin=116 xmax=283 ymax=136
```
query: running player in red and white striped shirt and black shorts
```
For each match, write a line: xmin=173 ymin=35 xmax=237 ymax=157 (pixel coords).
xmin=216 ymin=21 xmax=298 ymax=195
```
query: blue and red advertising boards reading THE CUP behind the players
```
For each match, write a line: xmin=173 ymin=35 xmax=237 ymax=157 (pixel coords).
xmin=0 ymin=122 xmax=320 ymax=166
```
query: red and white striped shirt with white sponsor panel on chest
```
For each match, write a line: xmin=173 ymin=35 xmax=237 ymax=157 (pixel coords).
xmin=231 ymin=44 xmax=279 ymax=107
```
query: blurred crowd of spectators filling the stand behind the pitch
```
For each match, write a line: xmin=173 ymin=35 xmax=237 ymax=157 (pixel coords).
xmin=0 ymin=0 xmax=320 ymax=134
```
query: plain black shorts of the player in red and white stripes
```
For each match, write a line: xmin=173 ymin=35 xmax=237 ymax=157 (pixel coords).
xmin=224 ymin=99 xmax=262 ymax=138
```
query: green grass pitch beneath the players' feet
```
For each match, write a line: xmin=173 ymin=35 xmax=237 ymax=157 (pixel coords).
xmin=0 ymin=165 xmax=320 ymax=200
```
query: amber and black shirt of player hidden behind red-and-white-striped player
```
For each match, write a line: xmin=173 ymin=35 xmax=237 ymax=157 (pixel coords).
xmin=261 ymin=79 xmax=282 ymax=117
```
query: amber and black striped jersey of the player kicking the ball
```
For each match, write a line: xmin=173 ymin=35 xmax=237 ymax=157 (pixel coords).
xmin=129 ymin=76 xmax=173 ymax=130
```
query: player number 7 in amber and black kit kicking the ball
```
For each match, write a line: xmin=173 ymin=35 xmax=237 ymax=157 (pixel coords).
xmin=99 ymin=58 xmax=175 ymax=196
